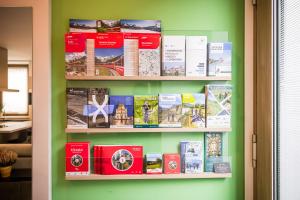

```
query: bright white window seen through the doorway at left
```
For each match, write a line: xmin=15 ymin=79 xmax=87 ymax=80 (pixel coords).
xmin=3 ymin=65 xmax=28 ymax=115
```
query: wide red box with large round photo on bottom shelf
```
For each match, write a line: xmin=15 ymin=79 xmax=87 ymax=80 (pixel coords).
xmin=101 ymin=145 xmax=143 ymax=175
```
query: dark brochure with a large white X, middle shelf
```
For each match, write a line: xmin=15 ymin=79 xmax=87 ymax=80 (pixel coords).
xmin=87 ymin=88 xmax=110 ymax=128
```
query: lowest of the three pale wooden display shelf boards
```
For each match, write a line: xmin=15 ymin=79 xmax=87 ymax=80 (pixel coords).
xmin=65 ymin=172 xmax=231 ymax=181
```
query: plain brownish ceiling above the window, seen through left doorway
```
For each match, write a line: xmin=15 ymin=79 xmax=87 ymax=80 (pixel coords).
xmin=0 ymin=7 xmax=32 ymax=61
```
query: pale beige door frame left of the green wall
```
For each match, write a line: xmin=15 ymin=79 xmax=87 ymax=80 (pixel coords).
xmin=0 ymin=0 xmax=52 ymax=200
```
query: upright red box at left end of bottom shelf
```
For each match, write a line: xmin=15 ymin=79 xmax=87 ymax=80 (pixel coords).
xmin=65 ymin=142 xmax=90 ymax=175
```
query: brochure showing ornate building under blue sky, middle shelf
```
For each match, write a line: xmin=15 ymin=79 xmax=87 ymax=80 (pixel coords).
xmin=109 ymin=96 xmax=134 ymax=128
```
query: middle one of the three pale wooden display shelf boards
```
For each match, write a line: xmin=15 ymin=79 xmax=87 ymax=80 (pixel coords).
xmin=65 ymin=128 xmax=231 ymax=134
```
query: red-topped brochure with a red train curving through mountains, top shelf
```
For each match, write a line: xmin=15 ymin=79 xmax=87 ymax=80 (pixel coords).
xmin=95 ymin=33 xmax=124 ymax=76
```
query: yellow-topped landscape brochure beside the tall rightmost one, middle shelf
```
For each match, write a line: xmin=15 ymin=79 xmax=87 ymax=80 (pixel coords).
xmin=181 ymin=93 xmax=205 ymax=128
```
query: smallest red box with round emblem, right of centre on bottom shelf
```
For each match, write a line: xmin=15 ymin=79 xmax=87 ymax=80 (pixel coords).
xmin=164 ymin=153 xmax=180 ymax=174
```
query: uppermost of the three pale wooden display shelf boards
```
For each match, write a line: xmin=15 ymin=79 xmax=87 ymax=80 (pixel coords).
xmin=65 ymin=75 xmax=231 ymax=81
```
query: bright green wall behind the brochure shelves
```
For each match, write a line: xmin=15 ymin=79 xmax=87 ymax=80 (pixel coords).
xmin=52 ymin=0 xmax=244 ymax=200
